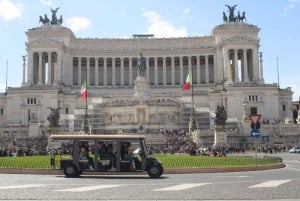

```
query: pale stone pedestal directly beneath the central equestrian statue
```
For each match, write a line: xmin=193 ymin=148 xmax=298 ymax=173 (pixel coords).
xmin=134 ymin=76 xmax=150 ymax=100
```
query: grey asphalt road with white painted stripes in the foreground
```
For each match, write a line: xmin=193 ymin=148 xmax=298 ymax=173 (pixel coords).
xmin=0 ymin=153 xmax=300 ymax=201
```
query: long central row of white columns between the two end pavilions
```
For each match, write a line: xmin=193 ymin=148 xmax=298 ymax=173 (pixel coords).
xmin=72 ymin=55 xmax=215 ymax=86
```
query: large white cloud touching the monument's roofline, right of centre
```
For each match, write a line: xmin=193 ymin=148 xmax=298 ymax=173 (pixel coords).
xmin=143 ymin=11 xmax=187 ymax=38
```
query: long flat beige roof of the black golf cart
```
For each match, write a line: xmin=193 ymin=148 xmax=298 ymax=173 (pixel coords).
xmin=50 ymin=134 xmax=145 ymax=141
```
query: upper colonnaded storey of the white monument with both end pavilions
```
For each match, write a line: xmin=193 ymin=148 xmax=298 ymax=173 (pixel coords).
xmin=23 ymin=23 xmax=263 ymax=87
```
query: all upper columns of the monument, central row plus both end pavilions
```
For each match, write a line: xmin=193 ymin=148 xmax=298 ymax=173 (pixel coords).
xmin=27 ymin=48 xmax=263 ymax=86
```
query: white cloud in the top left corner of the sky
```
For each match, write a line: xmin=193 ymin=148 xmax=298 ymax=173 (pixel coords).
xmin=0 ymin=0 xmax=23 ymax=21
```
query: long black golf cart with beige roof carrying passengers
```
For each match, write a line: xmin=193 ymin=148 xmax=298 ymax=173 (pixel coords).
xmin=50 ymin=134 xmax=163 ymax=178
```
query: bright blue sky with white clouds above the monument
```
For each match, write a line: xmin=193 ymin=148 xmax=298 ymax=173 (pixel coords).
xmin=0 ymin=0 xmax=300 ymax=101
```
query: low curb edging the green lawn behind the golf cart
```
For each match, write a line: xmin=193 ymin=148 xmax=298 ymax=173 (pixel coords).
xmin=0 ymin=163 xmax=286 ymax=175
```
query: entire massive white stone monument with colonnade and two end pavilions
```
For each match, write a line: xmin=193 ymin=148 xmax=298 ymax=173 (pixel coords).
xmin=0 ymin=14 xmax=293 ymax=150
